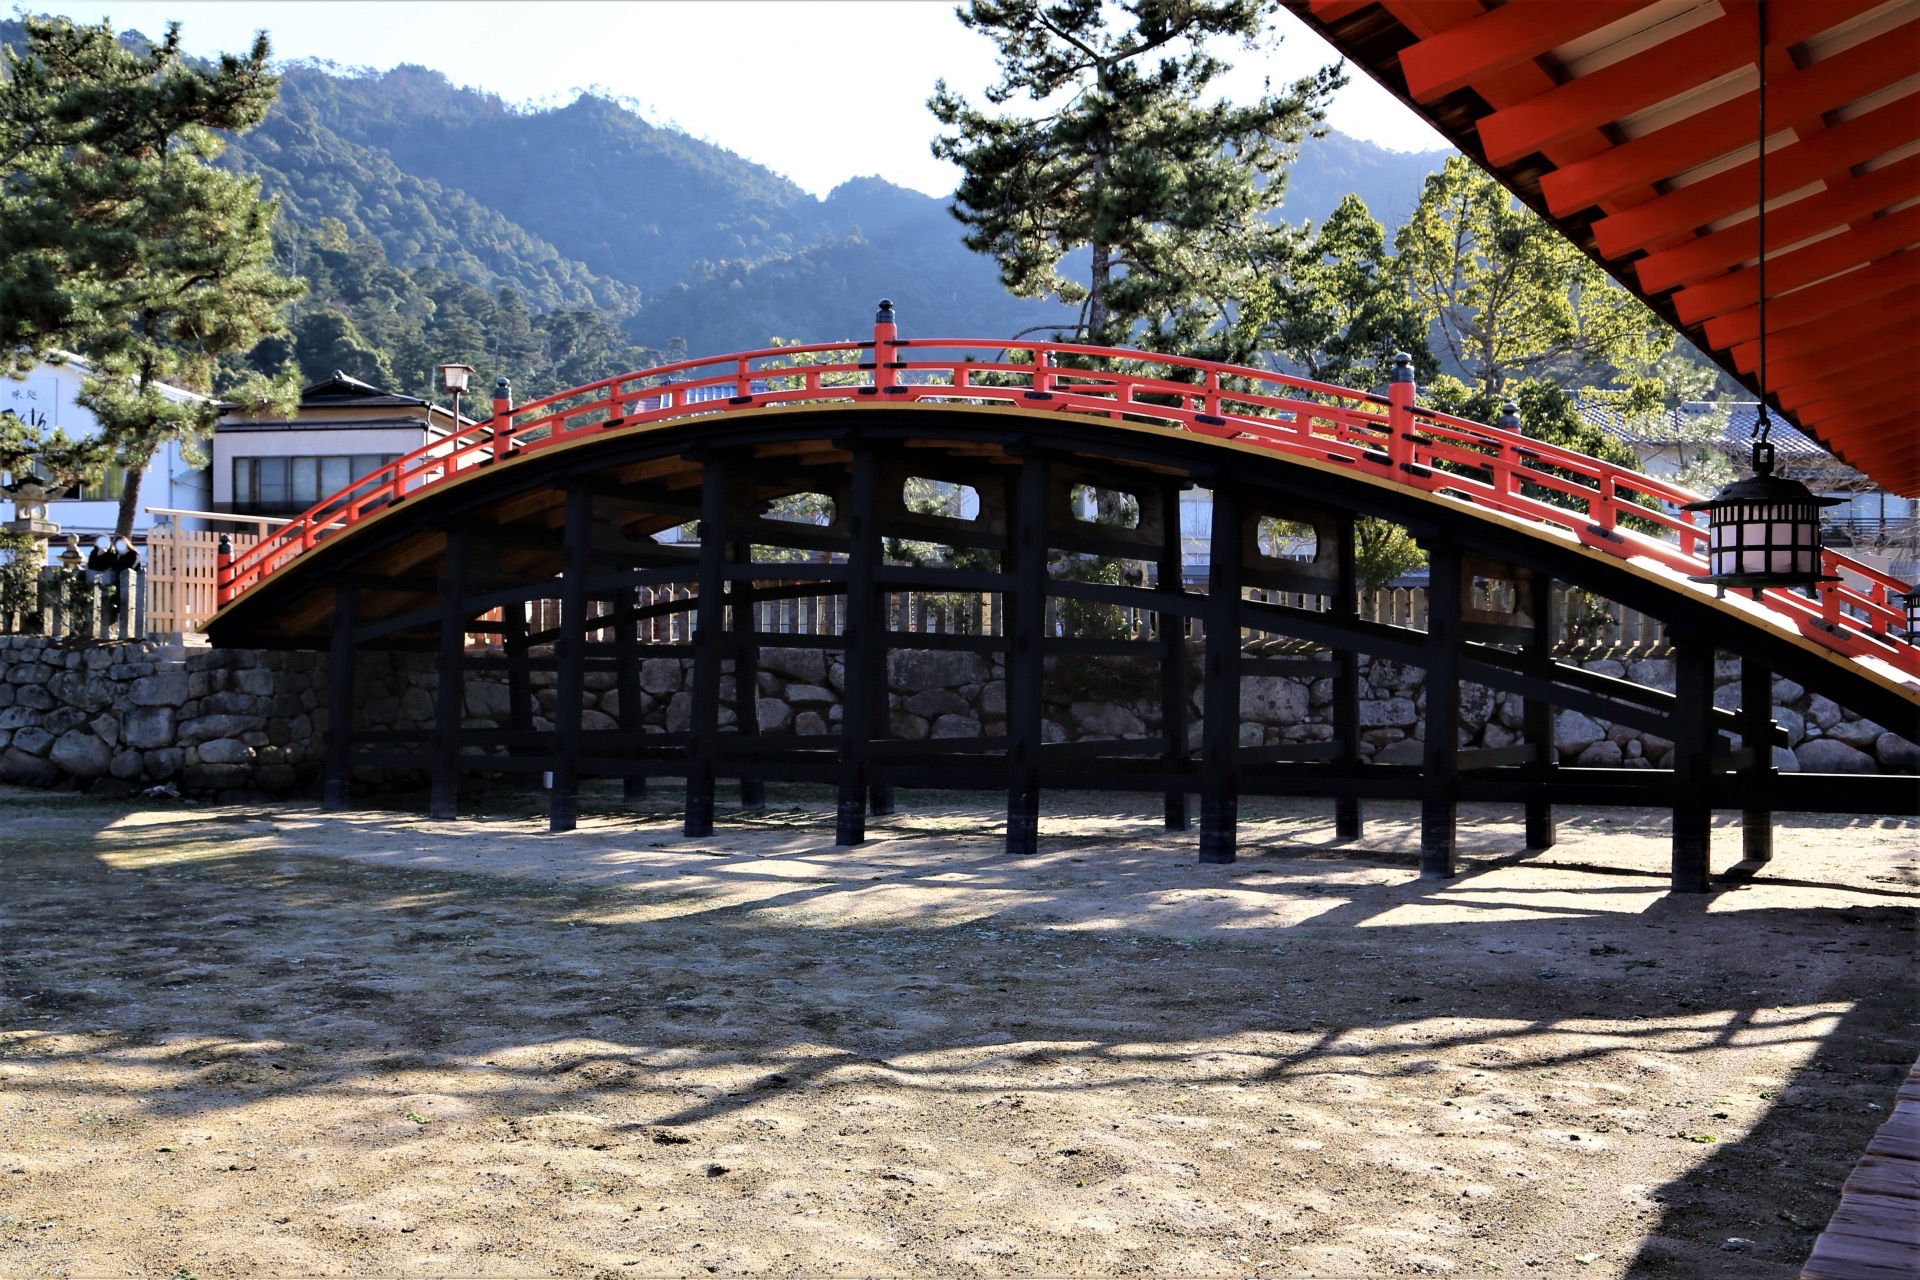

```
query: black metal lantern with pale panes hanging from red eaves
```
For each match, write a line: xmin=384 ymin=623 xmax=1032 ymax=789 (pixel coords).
xmin=1682 ymin=435 xmax=1839 ymax=599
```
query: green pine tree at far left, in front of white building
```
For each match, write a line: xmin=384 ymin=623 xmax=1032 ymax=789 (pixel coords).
xmin=0 ymin=19 xmax=301 ymax=533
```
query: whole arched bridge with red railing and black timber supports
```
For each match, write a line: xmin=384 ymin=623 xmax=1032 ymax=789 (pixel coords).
xmin=209 ymin=309 xmax=1920 ymax=887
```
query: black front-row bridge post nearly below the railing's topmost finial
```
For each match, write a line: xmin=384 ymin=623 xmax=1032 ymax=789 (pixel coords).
xmin=833 ymin=449 xmax=887 ymax=844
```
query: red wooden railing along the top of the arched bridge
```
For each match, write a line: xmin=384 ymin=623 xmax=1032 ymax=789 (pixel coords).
xmin=219 ymin=314 xmax=1920 ymax=679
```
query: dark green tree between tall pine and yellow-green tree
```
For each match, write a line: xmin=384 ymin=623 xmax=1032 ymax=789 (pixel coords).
xmin=1258 ymin=196 xmax=1436 ymax=390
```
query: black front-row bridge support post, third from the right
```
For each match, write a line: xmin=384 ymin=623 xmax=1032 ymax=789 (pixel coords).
xmin=1200 ymin=489 xmax=1244 ymax=862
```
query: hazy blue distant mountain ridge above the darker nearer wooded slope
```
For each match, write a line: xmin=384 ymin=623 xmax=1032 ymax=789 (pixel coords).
xmin=0 ymin=19 xmax=1446 ymax=362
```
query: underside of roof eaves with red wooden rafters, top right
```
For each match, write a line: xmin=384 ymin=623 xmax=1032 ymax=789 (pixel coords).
xmin=1292 ymin=0 xmax=1920 ymax=495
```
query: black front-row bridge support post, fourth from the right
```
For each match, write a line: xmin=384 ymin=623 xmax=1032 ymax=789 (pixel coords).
xmin=1006 ymin=455 xmax=1052 ymax=858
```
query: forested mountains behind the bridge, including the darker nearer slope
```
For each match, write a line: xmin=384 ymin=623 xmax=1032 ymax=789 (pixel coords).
xmin=0 ymin=21 xmax=1444 ymax=397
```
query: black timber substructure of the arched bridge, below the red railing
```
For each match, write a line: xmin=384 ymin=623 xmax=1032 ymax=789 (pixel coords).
xmin=217 ymin=413 xmax=1920 ymax=890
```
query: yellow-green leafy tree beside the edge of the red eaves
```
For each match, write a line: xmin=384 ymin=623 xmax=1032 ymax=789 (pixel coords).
xmin=1394 ymin=155 xmax=1674 ymax=395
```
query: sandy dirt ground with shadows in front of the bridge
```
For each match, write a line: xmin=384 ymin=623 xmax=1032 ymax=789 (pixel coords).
xmin=0 ymin=787 xmax=1920 ymax=1280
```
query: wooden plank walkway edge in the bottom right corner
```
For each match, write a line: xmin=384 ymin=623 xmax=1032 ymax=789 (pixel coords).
xmin=1801 ymin=1063 xmax=1920 ymax=1280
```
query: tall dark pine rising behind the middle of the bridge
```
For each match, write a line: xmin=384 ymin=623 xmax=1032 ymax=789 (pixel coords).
xmin=927 ymin=0 xmax=1344 ymax=353
